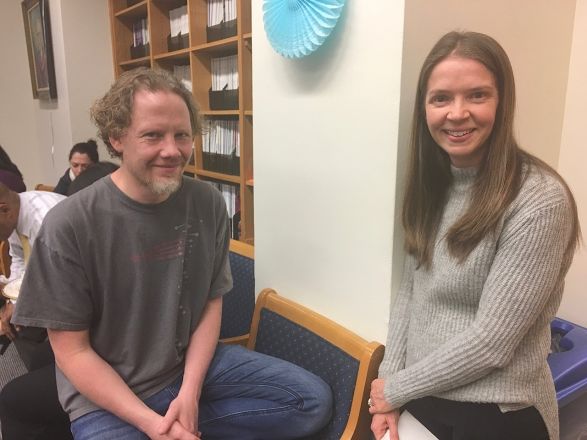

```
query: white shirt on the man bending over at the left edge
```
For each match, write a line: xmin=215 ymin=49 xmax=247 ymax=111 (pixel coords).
xmin=6 ymin=191 xmax=66 ymax=281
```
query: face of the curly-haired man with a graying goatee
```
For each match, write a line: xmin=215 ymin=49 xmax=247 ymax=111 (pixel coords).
xmin=110 ymin=90 xmax=193 ymax=203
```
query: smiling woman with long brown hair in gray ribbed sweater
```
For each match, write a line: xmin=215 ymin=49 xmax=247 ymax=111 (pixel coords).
xmin=369 ymin=32 xmax=580 ymax=440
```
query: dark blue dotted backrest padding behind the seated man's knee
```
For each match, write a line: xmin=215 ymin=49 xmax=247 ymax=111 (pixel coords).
xmin=255 ymin=309 xmax=359 ymax=440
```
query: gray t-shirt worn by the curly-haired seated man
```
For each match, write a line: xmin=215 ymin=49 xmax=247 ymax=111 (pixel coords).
xmin=12 ymin=177 xmax=232 ymax=420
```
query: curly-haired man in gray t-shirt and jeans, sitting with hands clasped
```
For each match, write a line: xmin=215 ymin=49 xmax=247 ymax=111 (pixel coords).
xmin=13 ymin=68 xmax=332 ymax=440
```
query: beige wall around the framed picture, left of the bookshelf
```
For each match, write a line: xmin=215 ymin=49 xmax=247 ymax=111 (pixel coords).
xmin=0 ymin=0 xmax=114 ymax=189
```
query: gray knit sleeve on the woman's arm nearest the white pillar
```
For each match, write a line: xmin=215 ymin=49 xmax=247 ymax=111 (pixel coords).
xmin=379 ymin=255 xmax=416 ymax=378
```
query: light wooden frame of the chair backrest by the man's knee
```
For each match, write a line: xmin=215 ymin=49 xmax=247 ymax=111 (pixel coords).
xmin=247 ymin=289 xmax=384 ymax=440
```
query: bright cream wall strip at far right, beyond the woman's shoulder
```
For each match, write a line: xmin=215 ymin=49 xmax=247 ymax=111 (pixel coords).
xmin=558 ymin=0 xmax=587 ymax=326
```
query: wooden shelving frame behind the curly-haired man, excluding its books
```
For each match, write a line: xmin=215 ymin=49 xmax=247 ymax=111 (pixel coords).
xmin=108 ymin=0 xmax=254 ymax=244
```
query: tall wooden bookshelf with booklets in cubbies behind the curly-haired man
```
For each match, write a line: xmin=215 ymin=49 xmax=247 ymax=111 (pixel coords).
xmin=108 ymin=0 xmax=254 ymax=247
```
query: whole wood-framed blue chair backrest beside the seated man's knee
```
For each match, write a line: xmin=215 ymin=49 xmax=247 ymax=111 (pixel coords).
xmin=247 ymin=289 xmax=384 ymax=440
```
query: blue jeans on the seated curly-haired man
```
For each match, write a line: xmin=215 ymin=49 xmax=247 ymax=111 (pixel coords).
xmin=71 ymin=344 xmax=332 ymax=440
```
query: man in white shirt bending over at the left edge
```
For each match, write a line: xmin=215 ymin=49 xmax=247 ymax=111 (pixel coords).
xmin=0 ymin=183 xmax=65 ymax=348
